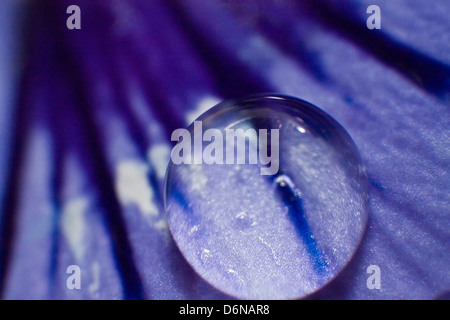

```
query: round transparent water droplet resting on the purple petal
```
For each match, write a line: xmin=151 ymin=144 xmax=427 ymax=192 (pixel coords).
xmin=165 ymin=95 xmax=368 ymax=299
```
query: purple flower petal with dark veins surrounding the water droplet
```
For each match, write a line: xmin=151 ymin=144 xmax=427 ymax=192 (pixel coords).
xmin=0 ymin=0 xmax=450 ymax=299
